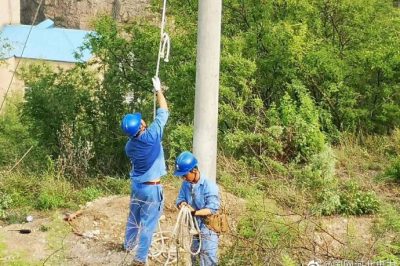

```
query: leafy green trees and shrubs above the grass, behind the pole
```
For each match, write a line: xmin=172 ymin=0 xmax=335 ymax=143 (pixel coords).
xmin=17 ymin=0 xmax=400 ymax=173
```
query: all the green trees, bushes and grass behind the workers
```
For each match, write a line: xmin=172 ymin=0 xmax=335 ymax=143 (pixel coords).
xmin=0 ymin=0 xmax=400 ymax=265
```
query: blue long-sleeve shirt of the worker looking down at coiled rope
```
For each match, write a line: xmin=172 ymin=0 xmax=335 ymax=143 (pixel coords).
xmin=176 ymin=176 xmax=220 ymax=227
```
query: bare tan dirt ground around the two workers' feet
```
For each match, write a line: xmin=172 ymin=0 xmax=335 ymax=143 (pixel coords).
xmin=0 ymin=184 xmax=245 ymax=265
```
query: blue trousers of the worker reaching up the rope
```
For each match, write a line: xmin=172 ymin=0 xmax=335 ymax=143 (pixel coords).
xmin=124 ymin=182 xmax=164 ymax=262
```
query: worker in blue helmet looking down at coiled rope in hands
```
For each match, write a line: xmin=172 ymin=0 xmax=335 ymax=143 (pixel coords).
xmin=174 ymin=151 xmax=220 ymax=266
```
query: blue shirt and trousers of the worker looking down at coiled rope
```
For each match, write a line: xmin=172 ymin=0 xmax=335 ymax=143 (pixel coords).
xmin=176 ymin=176 xmax=220 ymax=266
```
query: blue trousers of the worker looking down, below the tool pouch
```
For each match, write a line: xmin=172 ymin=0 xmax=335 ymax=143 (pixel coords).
xmin=192 ymin=222 xmax=218 ymax=266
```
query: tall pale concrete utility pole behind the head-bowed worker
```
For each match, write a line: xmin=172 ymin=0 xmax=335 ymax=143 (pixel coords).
xmin=193 ymin=0 xmax=222 ymax=182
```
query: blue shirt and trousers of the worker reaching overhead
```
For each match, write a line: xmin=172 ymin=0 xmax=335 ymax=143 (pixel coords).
xmin=124 ymin=108 xmax=169 ymax=262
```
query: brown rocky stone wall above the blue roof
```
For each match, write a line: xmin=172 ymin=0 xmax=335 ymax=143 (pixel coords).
xmin=21 ymin=0 xmax=150 ymax=29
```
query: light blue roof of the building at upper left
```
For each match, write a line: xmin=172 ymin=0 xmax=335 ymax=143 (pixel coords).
xmin=0 ymin=19 xmax=92 ymax=63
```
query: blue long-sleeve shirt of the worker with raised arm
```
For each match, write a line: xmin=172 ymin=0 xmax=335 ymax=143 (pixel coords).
xmin=125 ymin=108 xmax=169 ymax=183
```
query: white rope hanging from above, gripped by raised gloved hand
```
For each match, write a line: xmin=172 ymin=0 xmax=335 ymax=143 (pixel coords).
xmin=153 ymin=0 xmax=170 ymax=118
